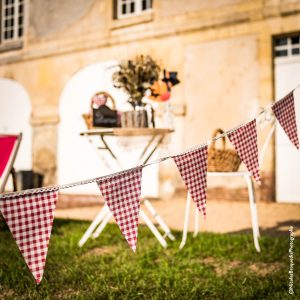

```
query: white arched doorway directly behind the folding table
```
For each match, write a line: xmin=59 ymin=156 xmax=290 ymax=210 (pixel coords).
xmin=58 ymin=61 xmax=159 ymax=196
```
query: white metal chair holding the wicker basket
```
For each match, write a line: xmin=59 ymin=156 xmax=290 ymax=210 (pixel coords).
xmin=179 ymin=113 xmax=275 ymax=252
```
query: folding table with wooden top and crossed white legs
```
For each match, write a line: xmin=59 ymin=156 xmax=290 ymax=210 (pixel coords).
xmin=79 ymin=128 xmax=175 ymax=248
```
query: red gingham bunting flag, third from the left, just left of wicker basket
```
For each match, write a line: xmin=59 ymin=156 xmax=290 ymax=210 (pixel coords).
xmin=173 ymin=146 xmax=207 ymax=217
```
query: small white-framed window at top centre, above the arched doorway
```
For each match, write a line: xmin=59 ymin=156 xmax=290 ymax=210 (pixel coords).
xmin=116 ymin=0 xmax=152 ymax=19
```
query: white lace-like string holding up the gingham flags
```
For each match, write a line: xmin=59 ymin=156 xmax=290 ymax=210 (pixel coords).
xmin=0 ymin=84 xmax=300 ymax=200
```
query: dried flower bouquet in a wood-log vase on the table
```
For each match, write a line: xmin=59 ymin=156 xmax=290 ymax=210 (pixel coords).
xmin=113 ymin=55 xmax=160 ymax=127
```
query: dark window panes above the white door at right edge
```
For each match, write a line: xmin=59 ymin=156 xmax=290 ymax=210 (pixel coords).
xmin=274 ymin=34 xmax=300 ymax=57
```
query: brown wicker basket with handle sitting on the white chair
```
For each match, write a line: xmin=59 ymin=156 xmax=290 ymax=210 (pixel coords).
xmin=208 ymin=129 xmax=241 ymax=172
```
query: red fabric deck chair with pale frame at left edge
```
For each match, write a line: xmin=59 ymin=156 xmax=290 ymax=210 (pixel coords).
xmin=0 ymin=133 xmax=22 ymax=193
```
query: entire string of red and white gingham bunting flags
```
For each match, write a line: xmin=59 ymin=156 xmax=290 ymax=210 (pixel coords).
xmin=0 ymin=85 xmax=299 ymax=284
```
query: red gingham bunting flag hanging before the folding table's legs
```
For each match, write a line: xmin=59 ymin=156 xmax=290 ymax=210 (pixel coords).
xmin=97 ymin=167 xmax=142 ymax=252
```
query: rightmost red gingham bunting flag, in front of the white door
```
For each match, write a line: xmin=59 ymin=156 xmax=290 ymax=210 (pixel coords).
xmin=272 ymin=92 xmax=299 ymax=149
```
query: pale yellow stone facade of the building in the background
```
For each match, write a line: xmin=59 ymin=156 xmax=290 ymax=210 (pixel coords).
xmin=0 ymin=0 xmax=300 ymax=200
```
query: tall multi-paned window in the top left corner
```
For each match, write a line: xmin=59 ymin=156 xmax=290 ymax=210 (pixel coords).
xmin=0 ymin=0 xmax=24 ymax=44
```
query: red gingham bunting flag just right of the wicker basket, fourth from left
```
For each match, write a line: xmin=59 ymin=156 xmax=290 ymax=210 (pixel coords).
xmin=227 ymin=119 xmax=260 ymax=183
